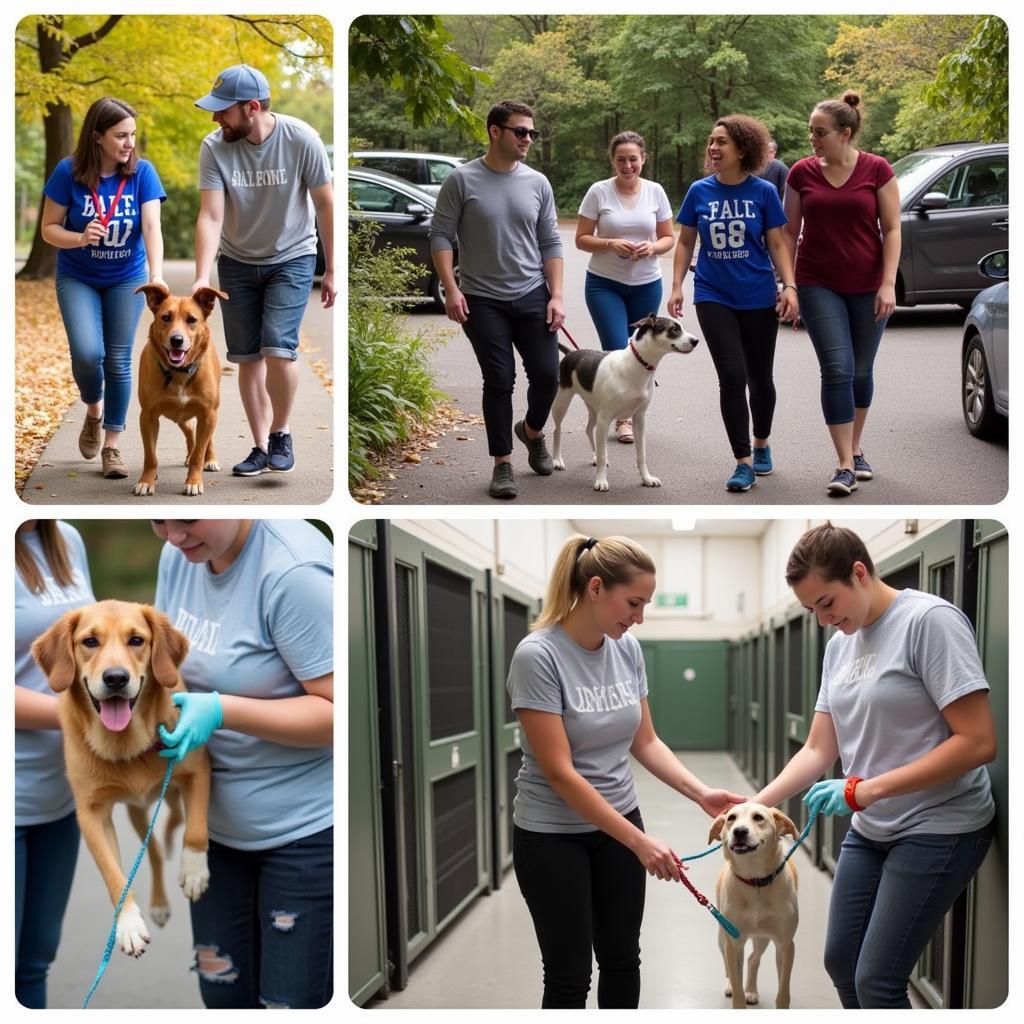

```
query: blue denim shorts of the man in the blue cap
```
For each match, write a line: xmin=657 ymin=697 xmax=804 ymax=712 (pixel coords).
xmin=217 ymin=254 xmax=316 ymax=362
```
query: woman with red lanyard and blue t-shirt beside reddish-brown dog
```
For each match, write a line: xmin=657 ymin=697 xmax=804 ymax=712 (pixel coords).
xmin=42 ymin=96 xmax=167 ymax=479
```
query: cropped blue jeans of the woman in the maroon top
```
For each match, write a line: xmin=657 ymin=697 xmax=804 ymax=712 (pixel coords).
xmin=800 ymin=285 xmax=888 ymax=426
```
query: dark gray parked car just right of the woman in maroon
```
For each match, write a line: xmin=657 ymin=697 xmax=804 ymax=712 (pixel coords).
xmin=893 ymin=142 xmax=1010 ymax=309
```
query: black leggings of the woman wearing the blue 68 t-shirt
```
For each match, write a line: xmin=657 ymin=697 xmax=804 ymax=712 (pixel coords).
xmin=694 ymin=302 xmax=778 ymax=459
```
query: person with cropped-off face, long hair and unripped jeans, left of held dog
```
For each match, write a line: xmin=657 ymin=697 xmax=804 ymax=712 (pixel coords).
xmin=14 ymin=519 xmax=94 ymax=1010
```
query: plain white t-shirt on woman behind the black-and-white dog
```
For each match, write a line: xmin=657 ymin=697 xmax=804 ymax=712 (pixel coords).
xmin=580 ymin=178 xmax=672 ymax=285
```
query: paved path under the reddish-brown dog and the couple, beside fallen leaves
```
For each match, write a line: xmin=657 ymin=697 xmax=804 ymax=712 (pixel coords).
xmin=22 ymin=260 xmax=334 ymax=511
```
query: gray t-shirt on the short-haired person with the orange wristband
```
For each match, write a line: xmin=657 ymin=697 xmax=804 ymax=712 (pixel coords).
xmin=815 ymin=590 xmax=995 ymax=842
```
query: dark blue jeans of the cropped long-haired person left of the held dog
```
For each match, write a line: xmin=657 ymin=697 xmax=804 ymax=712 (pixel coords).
xmin=14 ymin=811 xmax=79 ymax=1010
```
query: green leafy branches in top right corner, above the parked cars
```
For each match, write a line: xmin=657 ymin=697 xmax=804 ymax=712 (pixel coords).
xmin=925 ymin=14 xmax=1010 ymax=142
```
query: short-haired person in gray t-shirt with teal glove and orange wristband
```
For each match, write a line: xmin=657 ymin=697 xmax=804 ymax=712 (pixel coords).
xmin=755 ymin=523 xmax=995 ymax=1010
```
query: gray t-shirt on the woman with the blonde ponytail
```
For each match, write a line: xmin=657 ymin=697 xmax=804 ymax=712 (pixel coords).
xmin=507 ymin=626 xmax=647 ymax=833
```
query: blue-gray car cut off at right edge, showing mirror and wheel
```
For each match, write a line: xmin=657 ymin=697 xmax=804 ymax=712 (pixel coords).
xmin=961 ymin=249 xmax=1010 ymax=437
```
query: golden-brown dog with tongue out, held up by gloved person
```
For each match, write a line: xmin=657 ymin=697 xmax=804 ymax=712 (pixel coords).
xmin=32 ymin=601 xmax=210 ymax=956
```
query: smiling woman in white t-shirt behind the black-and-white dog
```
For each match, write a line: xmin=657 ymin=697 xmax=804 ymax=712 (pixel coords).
xmin=575 ymin=131 xmax=675 ymax=444
